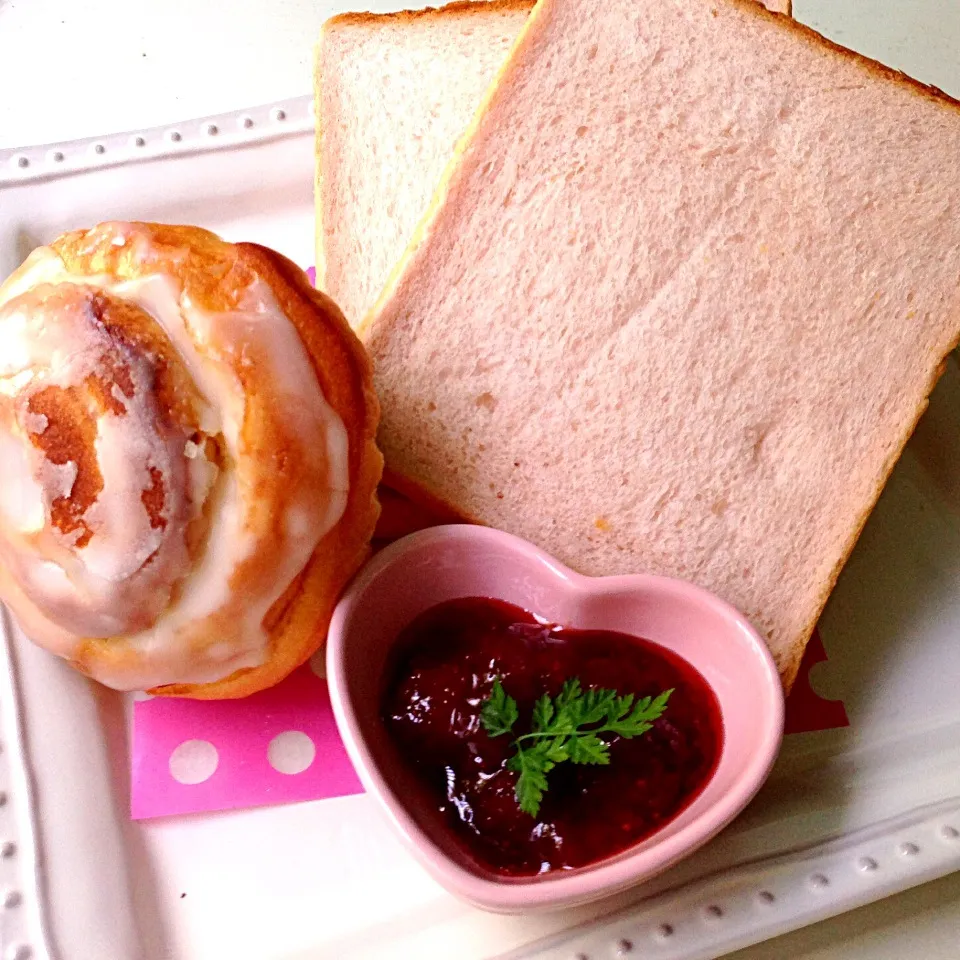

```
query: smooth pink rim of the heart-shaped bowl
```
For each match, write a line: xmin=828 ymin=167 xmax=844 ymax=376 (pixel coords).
xmin=326 ymin=523 xmax=785 ymax=913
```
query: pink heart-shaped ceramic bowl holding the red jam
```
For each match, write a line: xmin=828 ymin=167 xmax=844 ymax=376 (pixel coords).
xmin=327 ymin=525 xmax=784 ymax=913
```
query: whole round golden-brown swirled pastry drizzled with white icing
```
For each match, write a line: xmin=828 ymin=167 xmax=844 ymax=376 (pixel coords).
xmin=0 ymin=223 xmax=381 ymax=696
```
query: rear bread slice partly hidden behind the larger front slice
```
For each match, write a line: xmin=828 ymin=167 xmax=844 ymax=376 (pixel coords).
xmin=315 ymin=0 xmax=790 ymax=323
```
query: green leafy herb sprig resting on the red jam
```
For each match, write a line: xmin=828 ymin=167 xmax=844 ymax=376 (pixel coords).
xmin=480 ymin=677 xmax=673 ymax=817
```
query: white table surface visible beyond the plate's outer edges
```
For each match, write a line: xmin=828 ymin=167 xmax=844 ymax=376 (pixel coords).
xmin=0 ymin=0 xmax=960 ymax=960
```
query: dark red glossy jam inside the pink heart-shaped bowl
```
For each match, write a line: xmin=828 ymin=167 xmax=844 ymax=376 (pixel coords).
xmin=382 ymin=598 xmax=723 ymax=876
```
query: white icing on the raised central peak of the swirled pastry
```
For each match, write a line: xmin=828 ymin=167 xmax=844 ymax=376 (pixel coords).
xmin=0 ymin=283 xmax=193 ymax=655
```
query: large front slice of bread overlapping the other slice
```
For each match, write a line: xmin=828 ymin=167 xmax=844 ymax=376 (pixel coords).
xmin=361 ymin=0 xmax=960 ymax=688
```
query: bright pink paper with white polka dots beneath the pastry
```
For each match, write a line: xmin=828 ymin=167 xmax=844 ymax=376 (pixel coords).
xmin=131 ymin=653 xmax=363 ymax=820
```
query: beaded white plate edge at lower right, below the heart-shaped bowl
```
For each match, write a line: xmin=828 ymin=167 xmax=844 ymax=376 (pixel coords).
xmin=501 ymin=797 xmax=960 ymax=960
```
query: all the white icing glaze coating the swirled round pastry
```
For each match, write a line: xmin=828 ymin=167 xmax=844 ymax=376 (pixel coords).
xmin=0 ymin=224 xmax=349 ymax=689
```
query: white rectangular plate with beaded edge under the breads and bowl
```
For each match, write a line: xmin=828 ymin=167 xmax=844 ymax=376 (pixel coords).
xmin=0 ymin=26 xmax=960 ymax=960
